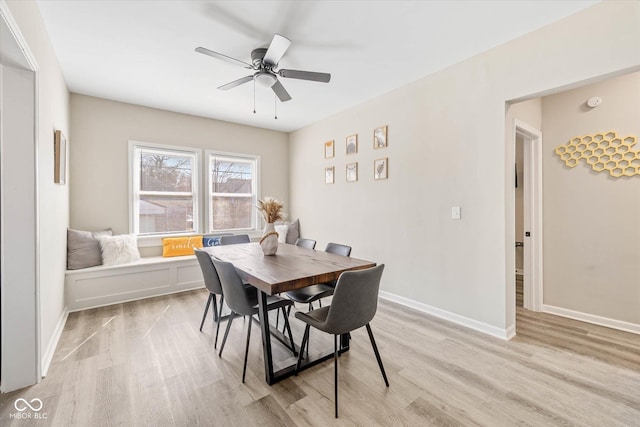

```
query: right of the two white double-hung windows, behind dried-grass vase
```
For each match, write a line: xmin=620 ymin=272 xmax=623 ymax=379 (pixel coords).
xmin=206 ymin=152 xmax=258 ymax=233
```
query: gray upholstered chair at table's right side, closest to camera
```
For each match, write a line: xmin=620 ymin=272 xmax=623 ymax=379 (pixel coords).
xmin=296 ymin=264 xmax=389 ymax=418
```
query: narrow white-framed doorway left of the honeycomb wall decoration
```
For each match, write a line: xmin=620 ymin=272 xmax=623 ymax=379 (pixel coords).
xmin=514 ymin=120 xmax=543 ymax=311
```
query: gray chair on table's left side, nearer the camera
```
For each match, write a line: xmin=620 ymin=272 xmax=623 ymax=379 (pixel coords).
xmin=212 ymin=258 xmax=298 ymax=382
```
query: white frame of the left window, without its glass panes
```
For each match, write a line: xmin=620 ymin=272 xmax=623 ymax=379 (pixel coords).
xmin=129 ymin=141 xmax=202 ymax=239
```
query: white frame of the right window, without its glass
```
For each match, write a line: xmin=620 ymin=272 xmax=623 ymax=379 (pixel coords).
xmin=202 ymin=150 xmax=261 ymax=235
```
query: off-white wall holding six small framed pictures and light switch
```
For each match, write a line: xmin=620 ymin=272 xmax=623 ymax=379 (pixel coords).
xmin=290 ymin=2 xmax=640 ymax=336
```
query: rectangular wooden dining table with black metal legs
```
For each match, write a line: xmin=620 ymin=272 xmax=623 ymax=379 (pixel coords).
xmin=203 ymin=243 xmax=376 ymax=385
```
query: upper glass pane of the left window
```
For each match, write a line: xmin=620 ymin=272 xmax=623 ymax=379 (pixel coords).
xmin=140 ymin=152 xmax=193 ymax=193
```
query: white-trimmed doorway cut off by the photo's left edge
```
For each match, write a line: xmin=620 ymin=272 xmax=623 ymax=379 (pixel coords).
xmin=0 ymin=3 xmax=41 ymax=392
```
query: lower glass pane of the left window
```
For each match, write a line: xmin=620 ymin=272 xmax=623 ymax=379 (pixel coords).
xmin=138 ymin=195 xmax=194 ymax=233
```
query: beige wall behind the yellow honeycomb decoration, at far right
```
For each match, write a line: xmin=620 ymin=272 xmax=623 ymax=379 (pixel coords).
xmin=542 ymin=72 xmax=640 ymax=324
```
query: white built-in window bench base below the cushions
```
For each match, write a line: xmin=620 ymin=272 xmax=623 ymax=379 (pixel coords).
xmin=65 ymin=255 xmax=204 ymax=311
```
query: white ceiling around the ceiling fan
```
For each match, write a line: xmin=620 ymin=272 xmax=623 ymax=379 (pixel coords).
xmin=38 ymin=0 xmax=597 ymax=131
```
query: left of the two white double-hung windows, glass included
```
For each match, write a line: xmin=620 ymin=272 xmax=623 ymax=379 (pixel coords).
xmin=130 ymin=143 xmax=199 ymax=235
